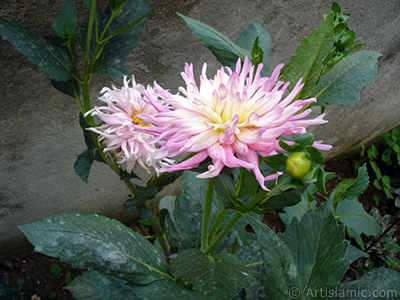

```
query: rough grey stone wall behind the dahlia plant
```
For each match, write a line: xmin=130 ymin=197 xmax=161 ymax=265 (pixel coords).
xmin=0 ymin=0 xmax=400 ymax=258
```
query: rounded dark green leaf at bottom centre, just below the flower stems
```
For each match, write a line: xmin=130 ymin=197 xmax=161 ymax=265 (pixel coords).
xmin=171 ymin=249 xmax=254 ymax=300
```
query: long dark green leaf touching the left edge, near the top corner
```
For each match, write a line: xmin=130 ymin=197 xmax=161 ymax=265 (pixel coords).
xmin=0 ymin=19 xmax=72 ymax=81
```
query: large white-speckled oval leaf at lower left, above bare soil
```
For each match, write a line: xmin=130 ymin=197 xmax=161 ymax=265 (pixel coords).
xmin=19 ymin=214 xmax=169 ymax=284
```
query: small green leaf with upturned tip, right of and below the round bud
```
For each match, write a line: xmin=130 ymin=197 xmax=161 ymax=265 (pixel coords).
xmin=332 ymin=165 xmax=369 ymax=203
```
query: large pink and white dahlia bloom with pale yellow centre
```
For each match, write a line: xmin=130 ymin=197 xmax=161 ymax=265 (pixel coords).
xmin=139 ymin=57 xmax=330 ymax=189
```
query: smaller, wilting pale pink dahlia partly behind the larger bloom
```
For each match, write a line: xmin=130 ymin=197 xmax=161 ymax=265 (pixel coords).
xmin=87 ymin=77 xmax=171 ymax=172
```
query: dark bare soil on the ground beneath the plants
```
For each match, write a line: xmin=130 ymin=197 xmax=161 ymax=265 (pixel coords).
xmin=0 ymin=158 xmax=400 ymax=300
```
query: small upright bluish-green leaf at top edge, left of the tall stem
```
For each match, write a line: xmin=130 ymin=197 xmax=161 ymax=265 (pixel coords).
xmin=53 ymin=0 xmax=77 ymax=40
